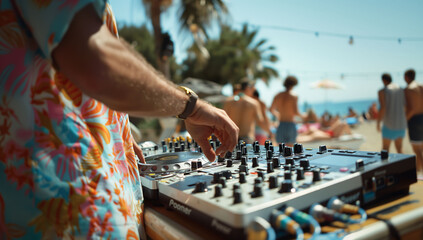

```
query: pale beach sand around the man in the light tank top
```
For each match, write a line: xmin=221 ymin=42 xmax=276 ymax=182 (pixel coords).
xmin=352 ymin=121 xmax=414 ymax=155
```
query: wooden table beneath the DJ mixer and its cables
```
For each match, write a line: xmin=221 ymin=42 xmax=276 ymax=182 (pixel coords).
xmin=145 ymin=181 xmax=423 ymax=240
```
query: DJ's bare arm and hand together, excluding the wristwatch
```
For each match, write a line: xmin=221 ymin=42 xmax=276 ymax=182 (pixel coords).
xmin=53 ymin=5 xmax=239 ymax=161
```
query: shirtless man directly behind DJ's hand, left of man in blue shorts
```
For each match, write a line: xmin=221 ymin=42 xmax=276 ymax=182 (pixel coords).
xmin=223 ymin=81 xmax=271 ymax=144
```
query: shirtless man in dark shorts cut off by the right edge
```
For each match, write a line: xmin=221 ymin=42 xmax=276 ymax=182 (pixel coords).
xmin=404 ymin=69 xmax=423 ymax=179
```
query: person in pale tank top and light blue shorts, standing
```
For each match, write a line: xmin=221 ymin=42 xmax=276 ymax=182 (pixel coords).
xmin=376 ymin=73 xmax=407 ymax=153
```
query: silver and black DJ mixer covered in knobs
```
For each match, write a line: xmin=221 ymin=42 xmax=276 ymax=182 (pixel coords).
xmin=139 ymin=138 xmax=417 ymax=239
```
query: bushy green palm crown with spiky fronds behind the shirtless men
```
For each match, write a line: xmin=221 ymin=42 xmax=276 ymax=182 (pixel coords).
xmin=182 ymin=25 xmax=278 ymax=84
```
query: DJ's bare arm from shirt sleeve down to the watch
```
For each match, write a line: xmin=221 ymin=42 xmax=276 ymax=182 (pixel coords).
xmin=53 ymin=5 xmax=188 ymax=116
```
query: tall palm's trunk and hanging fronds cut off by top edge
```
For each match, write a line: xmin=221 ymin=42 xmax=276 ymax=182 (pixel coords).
xmin=142 ymin=0 xmax=228 ymax=77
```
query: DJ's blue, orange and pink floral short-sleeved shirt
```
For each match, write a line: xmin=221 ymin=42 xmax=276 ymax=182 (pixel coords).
xmin=0 ymin=0 xmax=143 ymax=239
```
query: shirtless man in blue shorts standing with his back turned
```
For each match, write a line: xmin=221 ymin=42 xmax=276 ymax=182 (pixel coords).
xmin=270 ymin=76 xmax=301 ymax=145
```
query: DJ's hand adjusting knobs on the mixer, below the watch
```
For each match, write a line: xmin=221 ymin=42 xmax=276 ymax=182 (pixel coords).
xmin=185 ymin=100 xmax=239 ymax=162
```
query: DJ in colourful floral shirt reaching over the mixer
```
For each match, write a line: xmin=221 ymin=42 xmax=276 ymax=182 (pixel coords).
xmin=0 ymin=0 xmax=238 ymax=239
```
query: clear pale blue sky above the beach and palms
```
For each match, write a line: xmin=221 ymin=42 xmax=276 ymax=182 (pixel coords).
xmin=111 ymin=0 xmax=423 ymax=104
